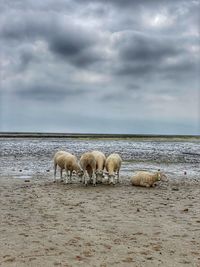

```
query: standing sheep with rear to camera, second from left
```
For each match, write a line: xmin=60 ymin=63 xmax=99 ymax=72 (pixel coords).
xmin=80 ymin=152 xmax=96 ymax=186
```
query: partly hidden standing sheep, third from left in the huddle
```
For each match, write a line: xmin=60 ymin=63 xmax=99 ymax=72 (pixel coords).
xmin=91 ymin=150 xmax=106 ymax=182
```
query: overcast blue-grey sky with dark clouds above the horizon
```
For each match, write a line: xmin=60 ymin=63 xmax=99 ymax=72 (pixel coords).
xmin=0 ymin=0 xmax=200 ymax=134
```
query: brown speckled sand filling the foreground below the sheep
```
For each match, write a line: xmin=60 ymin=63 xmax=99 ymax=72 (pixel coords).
xmin=0 ymin=176 xmax=200 ymax=267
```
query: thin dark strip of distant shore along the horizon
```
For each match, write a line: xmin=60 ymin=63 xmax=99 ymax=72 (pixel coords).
xmin=0 ymin=132 xmax=200 ymax=141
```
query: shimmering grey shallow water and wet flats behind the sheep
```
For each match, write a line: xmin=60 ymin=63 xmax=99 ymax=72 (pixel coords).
xmin=0 ymin=138 xmax=200 ymax=182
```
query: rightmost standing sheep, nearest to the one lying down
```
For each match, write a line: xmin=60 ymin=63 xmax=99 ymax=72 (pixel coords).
xmin=105 ymin=153 xmax=122 ymax=184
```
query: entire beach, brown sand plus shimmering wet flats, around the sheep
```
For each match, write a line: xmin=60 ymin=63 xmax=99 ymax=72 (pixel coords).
xmin=0 ymin=137 xmax=200 ymax=267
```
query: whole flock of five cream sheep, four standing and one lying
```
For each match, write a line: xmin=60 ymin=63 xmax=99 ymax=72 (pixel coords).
xmin=53 ymin=150 xmax=167 ymax=187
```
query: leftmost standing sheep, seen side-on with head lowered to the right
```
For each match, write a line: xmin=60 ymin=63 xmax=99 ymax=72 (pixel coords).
xmin=54 ymin=151 xmax=82 ymax=184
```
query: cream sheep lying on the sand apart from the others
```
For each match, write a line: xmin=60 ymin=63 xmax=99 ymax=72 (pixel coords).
xmin=131 ymin=171 xmax=167 ymax=187
